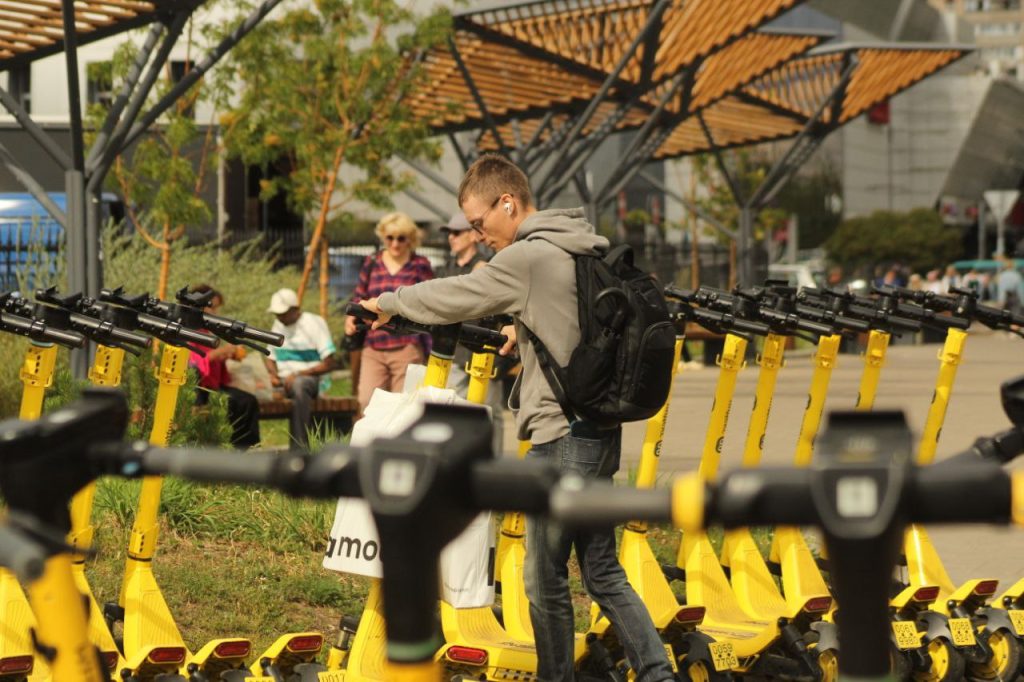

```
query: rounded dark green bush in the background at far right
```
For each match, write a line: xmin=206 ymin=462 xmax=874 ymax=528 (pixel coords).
xmin=824 ymin=208 xmax=961 ymax=272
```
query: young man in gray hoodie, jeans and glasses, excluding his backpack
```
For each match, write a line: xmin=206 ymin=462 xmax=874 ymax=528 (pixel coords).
xmin=362 ymin=155 xmax=675 ymax=682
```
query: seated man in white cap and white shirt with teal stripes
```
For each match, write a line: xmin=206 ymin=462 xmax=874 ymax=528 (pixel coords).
xmin=266 ymin=289 xmax=336 ymax=450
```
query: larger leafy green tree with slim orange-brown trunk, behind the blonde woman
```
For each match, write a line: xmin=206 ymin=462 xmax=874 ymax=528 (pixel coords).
xmin=221 ymin=0 xmax=451 ymax=315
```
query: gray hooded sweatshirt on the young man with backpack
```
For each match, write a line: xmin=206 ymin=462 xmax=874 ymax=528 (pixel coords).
xmin=379 ymin=209 xmax=608 ymax=444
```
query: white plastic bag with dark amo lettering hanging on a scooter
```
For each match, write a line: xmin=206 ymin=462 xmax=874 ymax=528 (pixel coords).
xmin=324 ymin=366 xmax=495 ymax=608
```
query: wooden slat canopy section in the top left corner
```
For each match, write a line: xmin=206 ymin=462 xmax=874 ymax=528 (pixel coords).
xmin=0 ymin=0 xmax=190 ymax=71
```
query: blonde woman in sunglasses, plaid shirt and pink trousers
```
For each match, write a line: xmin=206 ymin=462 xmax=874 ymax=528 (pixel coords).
xmin=345 ymin=212 xmax=434 ymax=412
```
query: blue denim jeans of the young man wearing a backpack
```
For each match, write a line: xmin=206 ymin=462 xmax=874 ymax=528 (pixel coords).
xmin=524 ymin=424 xmax=676 ymax=682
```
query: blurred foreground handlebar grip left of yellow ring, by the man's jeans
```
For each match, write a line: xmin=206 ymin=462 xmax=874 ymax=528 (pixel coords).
xmin=550 ymin=474 xmax=672 ymax=527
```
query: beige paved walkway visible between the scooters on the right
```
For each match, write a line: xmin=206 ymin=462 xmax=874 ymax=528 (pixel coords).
xmin=506 ymin=331 xmax=1024 ymax=588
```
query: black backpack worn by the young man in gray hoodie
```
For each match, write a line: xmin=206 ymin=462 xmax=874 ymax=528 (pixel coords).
xmin=526 ymin=245 xmax=676 ymax=427
